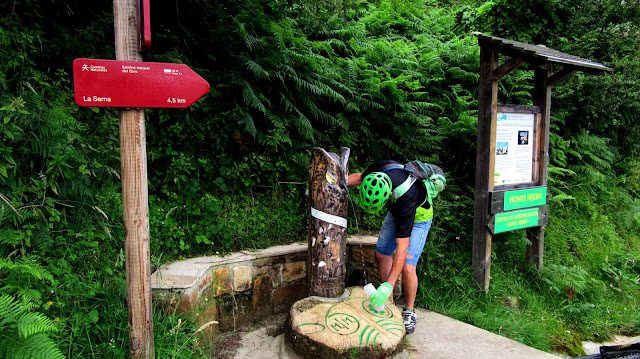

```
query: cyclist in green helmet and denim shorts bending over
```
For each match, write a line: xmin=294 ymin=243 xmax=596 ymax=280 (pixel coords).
xmin=347 ymin=160 xmax=446 ymax=334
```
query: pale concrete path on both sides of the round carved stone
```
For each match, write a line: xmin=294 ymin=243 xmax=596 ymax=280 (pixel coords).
xmin=233 ymin=309 xmax=561 ymax=359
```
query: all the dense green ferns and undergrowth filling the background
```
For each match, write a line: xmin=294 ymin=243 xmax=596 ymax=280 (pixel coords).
xmin=0 ymin=0 xmax=640 ymax=358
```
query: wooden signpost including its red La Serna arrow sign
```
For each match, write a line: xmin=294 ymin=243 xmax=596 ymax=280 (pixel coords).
xmin=73 ymin=0 xmax=209 ymax=358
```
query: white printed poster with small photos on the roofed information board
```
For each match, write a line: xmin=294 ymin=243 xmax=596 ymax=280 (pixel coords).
xmin=493 ymin=112 xmax=535 ymax=186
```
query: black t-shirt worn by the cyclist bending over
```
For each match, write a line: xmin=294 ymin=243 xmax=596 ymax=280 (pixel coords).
xmin=362 ymin=160 xmax=430 ymax=238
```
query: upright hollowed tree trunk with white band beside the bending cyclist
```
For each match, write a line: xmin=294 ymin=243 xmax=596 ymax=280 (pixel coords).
xmin=307 ymin=147 xmax=350 ymax=298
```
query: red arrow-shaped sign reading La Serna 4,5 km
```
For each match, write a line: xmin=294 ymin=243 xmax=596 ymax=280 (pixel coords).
xmin=73 ymin=59 xmax=209 ymax=108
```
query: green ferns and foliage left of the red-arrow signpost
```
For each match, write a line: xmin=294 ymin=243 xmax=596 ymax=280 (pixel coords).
xmin=0 ymin=1 xmax=127 ymax=358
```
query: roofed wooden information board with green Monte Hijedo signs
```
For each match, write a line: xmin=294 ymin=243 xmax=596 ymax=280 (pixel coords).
xmin=472 ymin=33 xmax=611 ymax=292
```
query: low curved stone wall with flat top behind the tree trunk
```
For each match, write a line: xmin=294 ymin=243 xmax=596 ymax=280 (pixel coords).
xmin=151 ymin=236 xmax=400 ymax=334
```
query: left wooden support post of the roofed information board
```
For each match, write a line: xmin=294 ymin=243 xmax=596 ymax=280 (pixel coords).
xmin=472 ymin=46 xmax=498 ymax=292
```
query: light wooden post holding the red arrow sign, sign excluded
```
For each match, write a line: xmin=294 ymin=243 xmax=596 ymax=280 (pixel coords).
xmin=113 ymin=0 xmax=154 ymax=358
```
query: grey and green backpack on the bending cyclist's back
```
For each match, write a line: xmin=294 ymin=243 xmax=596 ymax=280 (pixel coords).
xmin=382 ymin=160 xmax=447 ymax=206
